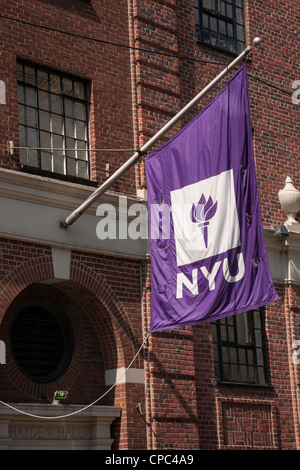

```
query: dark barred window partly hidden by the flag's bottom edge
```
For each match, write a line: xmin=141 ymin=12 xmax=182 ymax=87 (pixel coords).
xmin=213 ymin=308 xmax=268 ymax=385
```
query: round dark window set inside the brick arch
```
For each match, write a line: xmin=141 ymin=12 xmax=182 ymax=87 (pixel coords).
xmin=10 ymin=302 xmax=73 ymax=383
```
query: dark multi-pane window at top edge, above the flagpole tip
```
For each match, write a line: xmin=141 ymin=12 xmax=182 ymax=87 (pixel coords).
xmin=195 ymin=0 xmax=245 ymax=54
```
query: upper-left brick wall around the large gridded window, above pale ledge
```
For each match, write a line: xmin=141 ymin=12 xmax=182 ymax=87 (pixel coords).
xmin=0 ymin=0 xmax=136 ymax=194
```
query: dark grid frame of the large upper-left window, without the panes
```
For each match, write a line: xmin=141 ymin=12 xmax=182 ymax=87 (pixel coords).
xmin=17 ymin=58 xmax=91 ymax=182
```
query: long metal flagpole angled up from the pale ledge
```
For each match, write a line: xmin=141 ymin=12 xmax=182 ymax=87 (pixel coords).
xmin=60 ymin=38 xmax=261 ymax=228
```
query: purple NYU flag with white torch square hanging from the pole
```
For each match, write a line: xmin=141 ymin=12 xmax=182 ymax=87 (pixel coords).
xmin=146 ymin=65 xmax=278 ymax=332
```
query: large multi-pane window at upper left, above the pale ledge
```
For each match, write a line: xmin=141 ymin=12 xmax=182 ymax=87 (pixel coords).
xmin=17 ymin=61 xmax=89 ymax=179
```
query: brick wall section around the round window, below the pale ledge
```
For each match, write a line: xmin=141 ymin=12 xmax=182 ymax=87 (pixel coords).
xmin=0 ymin=239 xmax=146 ymax=448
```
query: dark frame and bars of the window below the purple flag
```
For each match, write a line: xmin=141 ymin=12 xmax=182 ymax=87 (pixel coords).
xmin=213 ymin=307 xmax=270 ymax=387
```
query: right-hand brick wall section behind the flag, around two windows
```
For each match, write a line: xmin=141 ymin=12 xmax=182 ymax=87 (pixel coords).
xmin=129 ymin=0 xmax=300 ymax=449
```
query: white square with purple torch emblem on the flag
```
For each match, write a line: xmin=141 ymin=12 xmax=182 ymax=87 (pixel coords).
xmin=171 ymin=170 xmax=241 ymax=266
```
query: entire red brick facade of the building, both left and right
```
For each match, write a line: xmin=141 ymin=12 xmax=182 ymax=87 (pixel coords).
xmin=0 ymin=0 xmax=300 ymax=450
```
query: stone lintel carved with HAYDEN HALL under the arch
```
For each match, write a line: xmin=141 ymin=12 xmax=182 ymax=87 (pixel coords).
xmin=0 ymin=403 xmax=121 ymax=450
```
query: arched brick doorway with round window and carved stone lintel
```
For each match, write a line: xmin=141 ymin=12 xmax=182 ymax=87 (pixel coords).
xmin=0 ymin=252 xmax=144 ymax=449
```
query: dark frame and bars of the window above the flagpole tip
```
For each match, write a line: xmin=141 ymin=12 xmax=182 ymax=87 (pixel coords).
xmin=194 ymin=0 xmax=247 ymax=55
